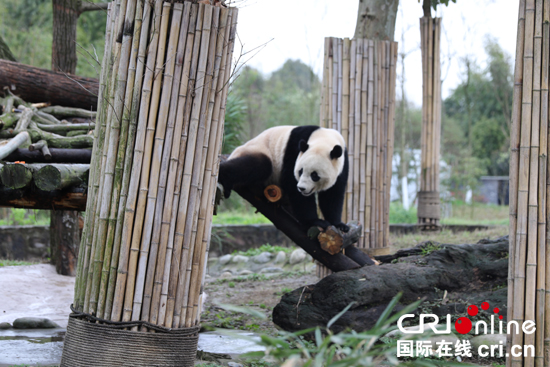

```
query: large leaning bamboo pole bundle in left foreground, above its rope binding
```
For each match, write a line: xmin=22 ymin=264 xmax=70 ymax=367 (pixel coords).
xmin=74 ymin=0 xmax=237 ymax=328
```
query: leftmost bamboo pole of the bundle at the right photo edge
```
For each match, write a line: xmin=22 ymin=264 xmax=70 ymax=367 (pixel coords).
xmin=506 ymin=0 xmax=525 ymax=367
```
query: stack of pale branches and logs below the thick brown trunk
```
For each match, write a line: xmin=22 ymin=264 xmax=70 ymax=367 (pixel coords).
xmin=0 ymin=92 xmax=95 ymax=210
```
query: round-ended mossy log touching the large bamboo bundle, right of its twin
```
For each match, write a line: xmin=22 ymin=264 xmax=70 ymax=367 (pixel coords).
xmin=33 ymin=164 xmax=90 ymax=191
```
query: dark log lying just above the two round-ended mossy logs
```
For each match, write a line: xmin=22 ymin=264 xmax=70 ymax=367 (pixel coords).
xmin=3 ymin=145 xmax=92 ymax=163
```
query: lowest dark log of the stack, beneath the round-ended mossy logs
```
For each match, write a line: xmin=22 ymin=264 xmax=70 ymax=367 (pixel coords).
xmin=0 ymin=186 xmax=87 ymax=211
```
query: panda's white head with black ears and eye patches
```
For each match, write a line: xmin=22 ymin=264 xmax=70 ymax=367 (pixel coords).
xmin=294 ymin=129 xmax=345 ymax=196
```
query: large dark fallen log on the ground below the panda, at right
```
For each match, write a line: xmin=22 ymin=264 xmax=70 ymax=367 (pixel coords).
xmin=273 ymin=237 xmax=508 ymax=332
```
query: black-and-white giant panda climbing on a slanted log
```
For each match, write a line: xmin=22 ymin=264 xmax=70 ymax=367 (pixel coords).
xmin=218 ymin=125 xmax=349 ymax=232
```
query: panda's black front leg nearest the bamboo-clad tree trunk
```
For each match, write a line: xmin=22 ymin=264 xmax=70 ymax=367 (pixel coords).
xmin=319 ymin=151 xmax=349 ymax=232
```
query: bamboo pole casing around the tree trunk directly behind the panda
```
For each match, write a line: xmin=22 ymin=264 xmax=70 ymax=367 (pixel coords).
xmin=318 ymin=38 xmax=397 ymax=277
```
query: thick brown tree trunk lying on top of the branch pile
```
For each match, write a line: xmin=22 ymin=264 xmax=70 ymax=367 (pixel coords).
xmin=0 ymin=60 xmax=99 ymax=111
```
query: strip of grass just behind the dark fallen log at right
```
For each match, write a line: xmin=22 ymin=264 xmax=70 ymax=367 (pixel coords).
xmin=390 ymin=226 xmax=508 ymax=253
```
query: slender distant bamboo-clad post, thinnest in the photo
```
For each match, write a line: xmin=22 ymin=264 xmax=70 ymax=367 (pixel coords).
xmin=417 ymin=17 xmax=441 ymax=230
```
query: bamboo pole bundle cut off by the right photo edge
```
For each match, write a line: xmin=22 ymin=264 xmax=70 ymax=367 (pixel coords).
xmin=506 ymin=0 xmax=550 ymax=366
